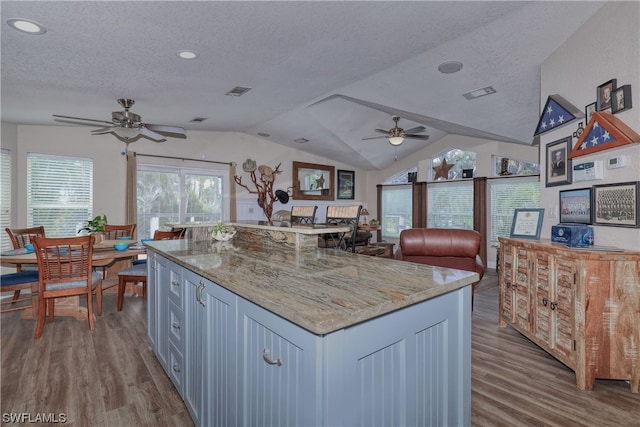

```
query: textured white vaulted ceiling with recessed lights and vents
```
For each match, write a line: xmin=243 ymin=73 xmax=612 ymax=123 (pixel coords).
xmin=0 ymin=1 xmax=603 ymax=169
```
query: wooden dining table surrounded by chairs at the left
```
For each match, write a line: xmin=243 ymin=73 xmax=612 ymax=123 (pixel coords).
xmin=0 ymin=240 xmax=147 ymax=320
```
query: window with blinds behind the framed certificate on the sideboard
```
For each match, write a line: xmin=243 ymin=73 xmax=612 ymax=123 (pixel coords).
xmin=489 ymin=176 xmax=540 ymax=246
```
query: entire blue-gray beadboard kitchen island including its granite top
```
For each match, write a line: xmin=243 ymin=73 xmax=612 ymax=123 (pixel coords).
xmin=146 ymin=240 xmax=478 ymax=426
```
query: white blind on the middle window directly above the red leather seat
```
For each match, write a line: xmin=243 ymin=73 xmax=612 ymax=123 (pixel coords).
xmin=427 ymin=181 xmax=473 ymax=230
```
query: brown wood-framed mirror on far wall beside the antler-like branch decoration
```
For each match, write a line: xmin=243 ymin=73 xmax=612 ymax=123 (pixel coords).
xmin=292 ymin=162 xmax=335 ymax=200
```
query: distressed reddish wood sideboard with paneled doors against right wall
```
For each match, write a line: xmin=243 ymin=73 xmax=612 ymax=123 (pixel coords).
xmin=499 ymin=238 xmax=640 ymax=393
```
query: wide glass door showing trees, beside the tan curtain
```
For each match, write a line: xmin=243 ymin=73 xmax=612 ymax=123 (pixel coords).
xmin=137 ymin=165 xmax=226 ymax=237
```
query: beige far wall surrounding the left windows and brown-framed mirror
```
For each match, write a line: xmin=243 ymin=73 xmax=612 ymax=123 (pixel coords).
xmin=10 ymin=125 xmax=366 ymax=227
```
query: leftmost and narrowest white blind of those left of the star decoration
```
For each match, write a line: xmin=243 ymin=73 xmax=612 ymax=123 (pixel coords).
xmin=380 ymin=184 xmax=413 ymax=238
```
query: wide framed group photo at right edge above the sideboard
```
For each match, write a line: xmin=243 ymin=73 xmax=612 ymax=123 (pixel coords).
xmin=593 ymin=182 xmax=640 ymax=228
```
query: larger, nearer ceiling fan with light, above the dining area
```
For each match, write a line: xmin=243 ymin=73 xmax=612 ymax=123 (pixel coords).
xmin=53 ymin=98 xmax=187 ymax=145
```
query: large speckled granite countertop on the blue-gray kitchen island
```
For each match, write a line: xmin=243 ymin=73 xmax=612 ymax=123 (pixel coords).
xmin=145 ymin=239 xmax=478 ymax=335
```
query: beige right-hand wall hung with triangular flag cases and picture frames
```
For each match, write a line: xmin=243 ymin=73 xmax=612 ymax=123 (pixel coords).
xmin=540 ymin=2 xmax=640 ymax=250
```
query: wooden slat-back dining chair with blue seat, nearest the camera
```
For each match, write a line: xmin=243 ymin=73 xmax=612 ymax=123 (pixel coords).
xmin=33 ymin=235 xmax=102 ymax=339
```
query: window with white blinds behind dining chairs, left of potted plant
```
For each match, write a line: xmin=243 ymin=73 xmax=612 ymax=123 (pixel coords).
xmin=27 ymin=153 xmax=93 ymax=237
